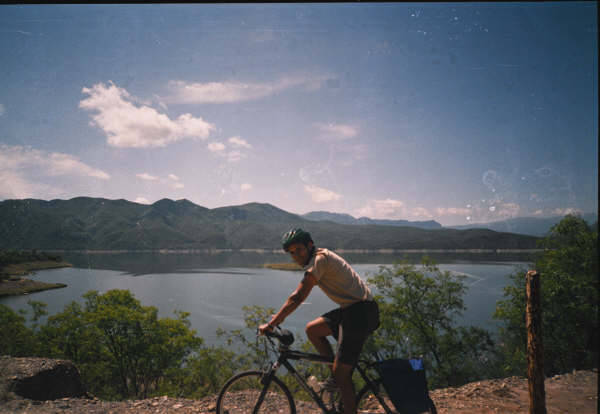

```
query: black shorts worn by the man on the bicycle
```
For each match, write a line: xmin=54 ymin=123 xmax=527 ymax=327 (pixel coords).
xmin=321 ymin=301 xmax=379 ymax=366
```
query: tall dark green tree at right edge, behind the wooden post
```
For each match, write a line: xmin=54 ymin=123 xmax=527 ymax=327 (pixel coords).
xmin=495 ymin=215 xmax=599 ymax=376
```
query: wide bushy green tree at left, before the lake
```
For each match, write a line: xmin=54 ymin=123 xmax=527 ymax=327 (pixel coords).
xmin=40 ymin=289 xmax=202 ymax=398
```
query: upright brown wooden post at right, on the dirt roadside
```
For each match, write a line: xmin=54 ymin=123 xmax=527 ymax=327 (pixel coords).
xmin=525 ymin=270 xmax=546 ymax=414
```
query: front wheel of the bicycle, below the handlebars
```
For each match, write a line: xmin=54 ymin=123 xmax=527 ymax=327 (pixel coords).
xmin=216 ymin=371 xmax=296 ymax=414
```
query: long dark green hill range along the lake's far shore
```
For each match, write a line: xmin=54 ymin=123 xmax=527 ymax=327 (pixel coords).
xmin=0 ymin=197 xmax=537 ymax=250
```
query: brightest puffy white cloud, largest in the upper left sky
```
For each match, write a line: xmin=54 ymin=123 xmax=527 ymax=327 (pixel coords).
xmin=79 ymin=81 xmax=215 ymax=148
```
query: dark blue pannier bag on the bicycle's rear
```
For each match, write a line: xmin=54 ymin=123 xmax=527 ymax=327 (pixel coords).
xmin=376 ymin=358 xmax=435 ymax=414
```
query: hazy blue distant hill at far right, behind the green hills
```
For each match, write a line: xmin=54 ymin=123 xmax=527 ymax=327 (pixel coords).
xmin=447 ymin=214 xmax=598 ymax=237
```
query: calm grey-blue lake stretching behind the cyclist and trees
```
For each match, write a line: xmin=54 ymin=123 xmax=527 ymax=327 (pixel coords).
xmin=0 ymin=252 xmax=528 ymax=344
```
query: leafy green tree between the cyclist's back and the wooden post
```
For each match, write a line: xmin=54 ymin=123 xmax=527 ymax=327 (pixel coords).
xmin=366 ymin=258 xmax=494 ymax=387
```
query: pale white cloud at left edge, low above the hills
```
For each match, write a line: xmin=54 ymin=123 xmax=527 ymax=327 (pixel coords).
xmin=0 ymin=144 xmax=110 ymax=198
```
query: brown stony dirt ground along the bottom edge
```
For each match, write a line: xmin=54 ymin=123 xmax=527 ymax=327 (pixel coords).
xmin=0 ymin=370 xmax=598 ymax=414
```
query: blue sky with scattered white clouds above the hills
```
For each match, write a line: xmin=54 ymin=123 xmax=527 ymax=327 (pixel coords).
xmin=0 ymin=2 xmax=598 ymax=225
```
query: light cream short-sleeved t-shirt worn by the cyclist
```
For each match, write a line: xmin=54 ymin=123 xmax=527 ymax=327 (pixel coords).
xmin=304 ymin=249 xmax=373 ymax=308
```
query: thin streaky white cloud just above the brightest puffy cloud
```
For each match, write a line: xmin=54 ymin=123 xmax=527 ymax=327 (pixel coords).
xmin=166 ymin=76 xmax=326 ymax=104
